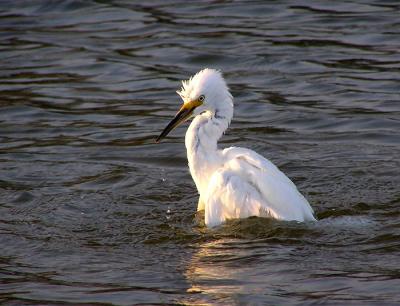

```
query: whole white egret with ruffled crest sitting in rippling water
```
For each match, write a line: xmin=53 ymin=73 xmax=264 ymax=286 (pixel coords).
xmin=156 ymin=69 xmax=315 ymax=227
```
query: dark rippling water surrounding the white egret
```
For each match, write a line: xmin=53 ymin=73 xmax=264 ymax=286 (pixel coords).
xmin=0 ymin=0 xmax=400 ymax=305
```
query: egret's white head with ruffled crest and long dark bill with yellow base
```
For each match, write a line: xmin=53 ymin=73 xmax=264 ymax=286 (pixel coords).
xmin=156 ymin=68 xmax=232 ymax=142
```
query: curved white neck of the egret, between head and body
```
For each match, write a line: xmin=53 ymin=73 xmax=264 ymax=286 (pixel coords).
xmin=185 ymin=105 xmax=233 ymax=193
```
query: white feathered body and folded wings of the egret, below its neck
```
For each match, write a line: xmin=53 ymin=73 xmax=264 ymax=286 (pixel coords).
xmin=205 ymin=147 xmax=315 ymax=225
